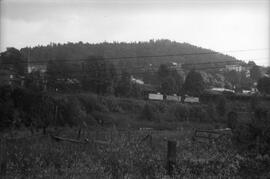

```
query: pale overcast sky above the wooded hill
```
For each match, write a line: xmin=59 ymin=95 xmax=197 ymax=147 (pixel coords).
xmin=1 ymin=0 xmax=270 ymax=66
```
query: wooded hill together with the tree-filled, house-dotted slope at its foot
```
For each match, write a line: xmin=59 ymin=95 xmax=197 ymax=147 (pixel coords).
xmin=0 ymin=40 xmax=268 ymax=96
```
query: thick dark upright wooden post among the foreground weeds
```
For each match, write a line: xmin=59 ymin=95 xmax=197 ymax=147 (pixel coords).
xmin=167 ymin=141 xmax=176 ymax=176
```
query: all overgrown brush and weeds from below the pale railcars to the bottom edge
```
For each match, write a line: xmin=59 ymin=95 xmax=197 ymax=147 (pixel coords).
xmin=0 ymin=87 xmax=270 ymax=178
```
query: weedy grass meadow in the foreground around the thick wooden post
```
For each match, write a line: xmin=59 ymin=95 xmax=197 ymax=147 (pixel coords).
xmin=0 ymin=122 xmax=270 ymax=178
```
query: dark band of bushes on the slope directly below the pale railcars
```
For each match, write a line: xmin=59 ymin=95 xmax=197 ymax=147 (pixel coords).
xmin=0 ymin=87 xmax=219 ymax=133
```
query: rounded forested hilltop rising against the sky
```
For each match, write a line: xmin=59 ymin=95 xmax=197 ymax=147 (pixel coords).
xmin=21 ymin=40 xmax=236 ymax=66
